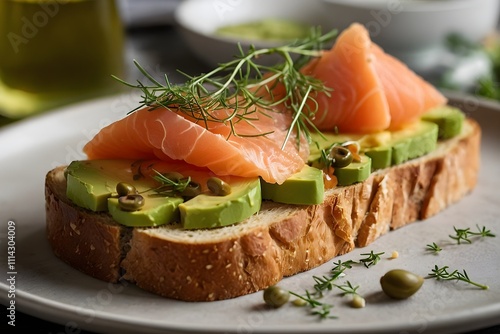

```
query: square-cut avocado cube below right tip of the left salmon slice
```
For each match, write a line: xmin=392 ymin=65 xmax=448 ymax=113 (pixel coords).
xmin=261 ymin=165 xmax=325 ymax=205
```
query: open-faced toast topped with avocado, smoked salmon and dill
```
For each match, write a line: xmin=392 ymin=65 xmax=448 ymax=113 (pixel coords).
xmin=46 ymin=24 xmax=480 ymax=301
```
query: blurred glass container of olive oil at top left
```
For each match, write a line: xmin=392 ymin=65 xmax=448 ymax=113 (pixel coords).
xmin=0 ymin=0 xmax=124 ymax=118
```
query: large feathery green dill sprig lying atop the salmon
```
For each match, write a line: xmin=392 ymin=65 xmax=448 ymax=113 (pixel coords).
xmin=115 ymin=28 xmax=337 ymax=146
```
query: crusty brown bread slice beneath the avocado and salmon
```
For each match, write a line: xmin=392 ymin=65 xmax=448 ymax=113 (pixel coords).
xmin=46 ymin=119 xmax=481 ymax=301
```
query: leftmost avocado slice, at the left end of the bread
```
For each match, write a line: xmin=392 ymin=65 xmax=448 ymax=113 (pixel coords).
xmin=66 ymin=160 xmax=154 ymax=211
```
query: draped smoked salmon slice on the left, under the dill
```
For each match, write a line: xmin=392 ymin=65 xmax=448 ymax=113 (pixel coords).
xmin=83 ymin=108 xmax=309 ymax=183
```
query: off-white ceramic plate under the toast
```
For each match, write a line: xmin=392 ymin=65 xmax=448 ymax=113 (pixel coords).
xmin=0 ymin=92 xmax=500 ymax=333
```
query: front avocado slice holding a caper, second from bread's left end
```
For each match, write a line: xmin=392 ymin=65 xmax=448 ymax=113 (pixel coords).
xmin=107 ymin=196 xmax=184 ymax=226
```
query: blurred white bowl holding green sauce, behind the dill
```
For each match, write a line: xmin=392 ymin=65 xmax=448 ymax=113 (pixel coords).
xmin=175 ymin=0 xmax=326 ymax=66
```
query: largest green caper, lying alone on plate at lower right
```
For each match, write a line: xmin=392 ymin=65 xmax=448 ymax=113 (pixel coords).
xmin=380 ymin=269 xmax=424 ymax=299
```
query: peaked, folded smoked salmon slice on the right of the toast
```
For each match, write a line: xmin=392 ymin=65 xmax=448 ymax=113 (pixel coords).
xmin=302 ymin=23 xmax=447 ymax=133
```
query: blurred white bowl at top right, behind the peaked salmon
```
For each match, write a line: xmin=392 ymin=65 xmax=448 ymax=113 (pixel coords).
xmin=324 ymin=0 xmax=500 ymax=73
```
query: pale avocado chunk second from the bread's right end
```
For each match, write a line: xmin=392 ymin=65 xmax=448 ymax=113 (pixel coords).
xmin=392 ymin=121 xmax=438 ymax=165
